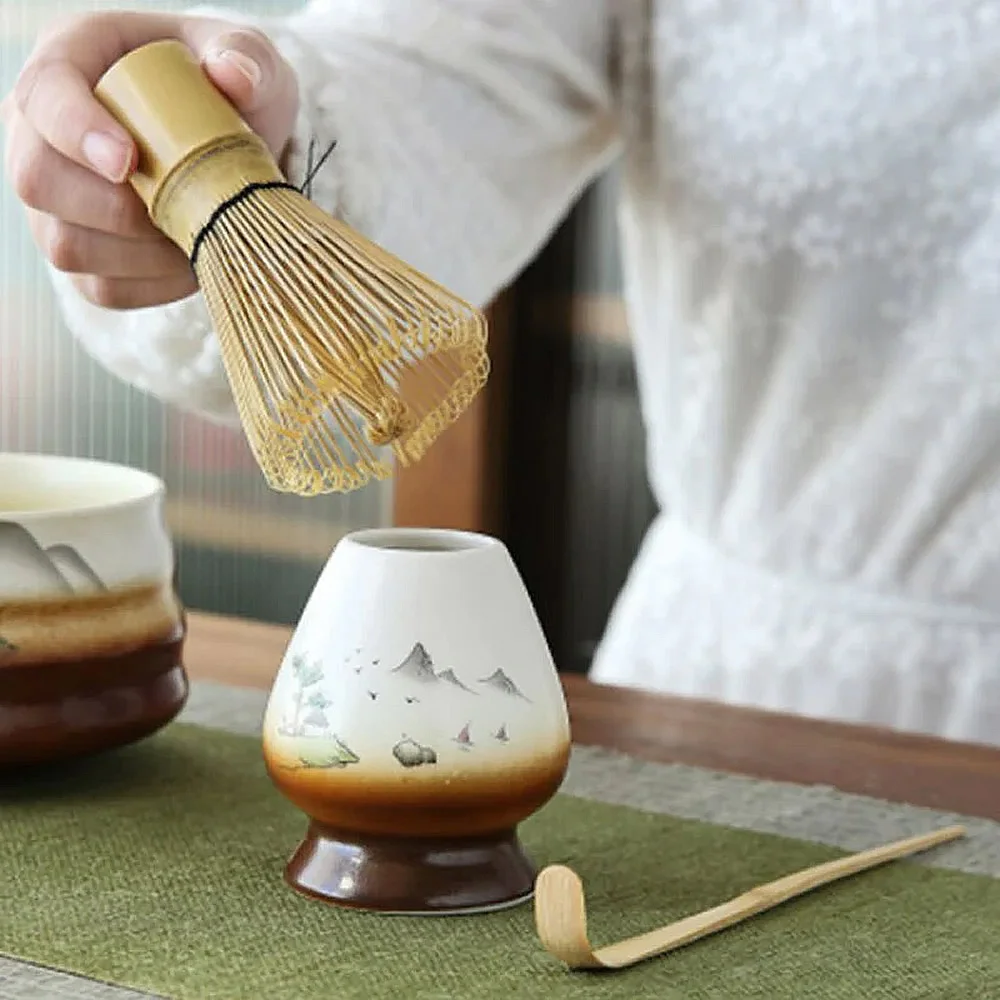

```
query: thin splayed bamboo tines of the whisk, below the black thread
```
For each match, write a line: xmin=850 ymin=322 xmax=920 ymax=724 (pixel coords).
xmin=197 ymin=185 xmax=489 ymax=495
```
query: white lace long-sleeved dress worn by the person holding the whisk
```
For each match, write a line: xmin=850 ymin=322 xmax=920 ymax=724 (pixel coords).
xmin=53 ymin=0 xmax=1000 ymax=744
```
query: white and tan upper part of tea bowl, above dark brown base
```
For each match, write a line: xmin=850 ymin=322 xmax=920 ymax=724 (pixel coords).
xmin=0 ymin=453 xmax=180 ymax=663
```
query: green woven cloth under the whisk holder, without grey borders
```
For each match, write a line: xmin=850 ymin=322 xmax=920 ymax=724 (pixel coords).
xmin=0 ymin=725 xmax=1000 ymax=1000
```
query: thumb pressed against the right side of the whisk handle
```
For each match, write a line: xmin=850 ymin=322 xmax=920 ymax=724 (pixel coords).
xmin=199 ymin=29 xmax=299 ymax=157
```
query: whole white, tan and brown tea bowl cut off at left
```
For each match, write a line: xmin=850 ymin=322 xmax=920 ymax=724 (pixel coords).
xmin=0 ymin=453 xmax=188 ymax=768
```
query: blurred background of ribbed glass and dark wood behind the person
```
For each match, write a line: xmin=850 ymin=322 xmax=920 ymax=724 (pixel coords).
xmin=0 ymin=0 xmax=653 ymax=671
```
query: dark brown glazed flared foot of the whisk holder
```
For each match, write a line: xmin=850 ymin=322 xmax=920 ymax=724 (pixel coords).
xmin=285 ymin=822 xmax=536 ymax=916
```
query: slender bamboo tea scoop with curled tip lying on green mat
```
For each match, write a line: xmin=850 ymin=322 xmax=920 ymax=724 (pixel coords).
xmin=535 ymin=826 xmax=966 ymax=969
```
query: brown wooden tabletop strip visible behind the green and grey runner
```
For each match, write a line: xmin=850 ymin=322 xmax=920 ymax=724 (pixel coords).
xmin=186 ymin=613 xmax=1000 ymax=820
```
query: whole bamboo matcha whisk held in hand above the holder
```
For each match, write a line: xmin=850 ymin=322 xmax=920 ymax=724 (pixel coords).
xmin=95 ymin=41 xmax=489 ymax=496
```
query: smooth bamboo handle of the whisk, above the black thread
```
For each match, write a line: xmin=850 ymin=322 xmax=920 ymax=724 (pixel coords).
xmin=94 ymin=40 xmax=284 ymax=256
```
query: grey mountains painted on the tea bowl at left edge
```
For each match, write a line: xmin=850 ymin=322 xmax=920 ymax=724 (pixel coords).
xmin=0 ymin=521 xmax=106 ymax=597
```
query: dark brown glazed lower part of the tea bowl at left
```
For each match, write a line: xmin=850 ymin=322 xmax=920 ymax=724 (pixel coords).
xmin=0 ymin=629 xmax=188 ymax=769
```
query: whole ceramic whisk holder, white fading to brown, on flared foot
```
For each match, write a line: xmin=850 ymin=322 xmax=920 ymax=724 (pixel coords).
xmin=264 ymin=529 xmax=570 ymax=914
